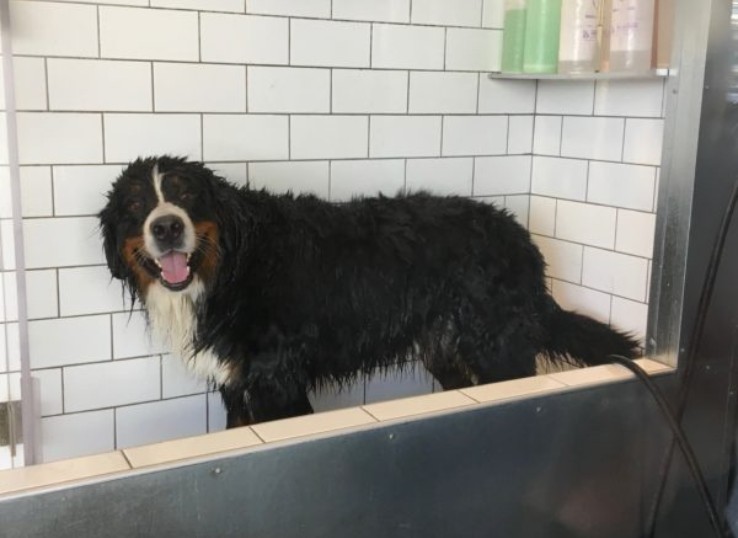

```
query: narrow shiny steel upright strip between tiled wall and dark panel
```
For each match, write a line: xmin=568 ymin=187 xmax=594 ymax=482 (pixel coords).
xmin=646 ymin=0 xmax=712 ymax=366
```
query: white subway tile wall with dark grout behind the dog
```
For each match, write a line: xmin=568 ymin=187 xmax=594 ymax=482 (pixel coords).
xmin=5 ymin=0 xmax=663 ymax=460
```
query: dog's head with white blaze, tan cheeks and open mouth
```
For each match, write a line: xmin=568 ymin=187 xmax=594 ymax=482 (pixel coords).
xmin=99 ymin=157 xmax=222 ymax=297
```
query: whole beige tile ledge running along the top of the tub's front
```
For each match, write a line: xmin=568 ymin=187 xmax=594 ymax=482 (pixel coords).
xmin=0 ymin=359 xmax=674 ymax=497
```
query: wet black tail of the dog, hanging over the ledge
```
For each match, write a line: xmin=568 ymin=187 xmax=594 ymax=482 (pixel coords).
xmin=541 ymin=300 xmax=640 ymax=366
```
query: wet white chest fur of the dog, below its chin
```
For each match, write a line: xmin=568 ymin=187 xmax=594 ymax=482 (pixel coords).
xmin=146 ymin=277 xmax=231 ymax=385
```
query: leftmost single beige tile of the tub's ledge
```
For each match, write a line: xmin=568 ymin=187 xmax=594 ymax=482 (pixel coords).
xmin=0 ymin=452 xmax=131 ymax=496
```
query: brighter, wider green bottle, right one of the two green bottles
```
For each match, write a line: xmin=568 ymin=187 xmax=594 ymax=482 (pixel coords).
xmin=523 ymin=0 xmax=561 ymax=73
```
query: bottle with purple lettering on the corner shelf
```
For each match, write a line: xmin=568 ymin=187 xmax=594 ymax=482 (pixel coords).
xmin=609 ymin=0 xmax=654 ymax=72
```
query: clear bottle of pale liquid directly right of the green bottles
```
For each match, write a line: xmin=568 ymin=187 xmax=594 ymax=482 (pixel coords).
xmin=559 ymin=0 xmax=610 ymax=74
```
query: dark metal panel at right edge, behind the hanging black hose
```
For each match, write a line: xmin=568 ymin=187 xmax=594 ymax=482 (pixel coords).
xmin=648 ymin=0 xmax=738 ymax=536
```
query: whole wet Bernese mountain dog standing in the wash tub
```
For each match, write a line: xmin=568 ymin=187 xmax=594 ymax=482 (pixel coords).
xmin=99 ymin=156 xmax=638 ymax=427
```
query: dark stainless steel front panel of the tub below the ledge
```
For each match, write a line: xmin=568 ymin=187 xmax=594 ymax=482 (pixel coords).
xmin=0 ymin=379 xmax=669 ymax=538
